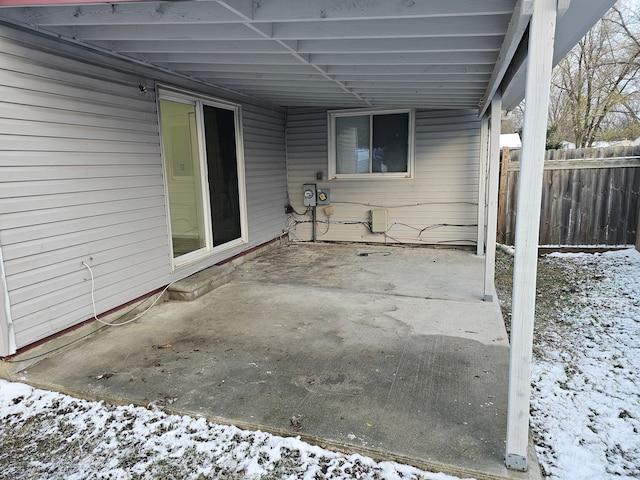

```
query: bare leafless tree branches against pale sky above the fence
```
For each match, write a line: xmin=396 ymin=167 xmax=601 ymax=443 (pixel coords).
xmin=549 ymin=0 xmax=640 ymax=147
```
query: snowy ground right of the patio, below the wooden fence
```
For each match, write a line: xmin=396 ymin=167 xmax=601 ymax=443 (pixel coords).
xmin=531 ymin=250 xmax=640 ymax=480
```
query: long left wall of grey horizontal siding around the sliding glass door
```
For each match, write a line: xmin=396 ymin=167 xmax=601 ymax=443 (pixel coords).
xmin=0 ymin=25 xmax=286 ymax=356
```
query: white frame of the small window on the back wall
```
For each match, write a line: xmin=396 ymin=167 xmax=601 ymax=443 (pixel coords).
xmin=327 ymin=108 xmax=416 ymax=180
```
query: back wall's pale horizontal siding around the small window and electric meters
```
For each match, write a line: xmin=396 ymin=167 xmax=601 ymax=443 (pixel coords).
xmin=287 ymin=108 xmax=481 ymax=245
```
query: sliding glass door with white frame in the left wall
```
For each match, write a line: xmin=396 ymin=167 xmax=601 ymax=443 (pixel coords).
xmin=158 ymin=89 xmax=247 ymax=266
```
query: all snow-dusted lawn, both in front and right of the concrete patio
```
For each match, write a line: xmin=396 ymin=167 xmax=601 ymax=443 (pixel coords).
xmin=0 ymin=246 xmax=640 ymax=480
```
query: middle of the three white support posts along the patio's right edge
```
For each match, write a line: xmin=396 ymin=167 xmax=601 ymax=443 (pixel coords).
xmin=484 ymin=92 xmax=502 ymax=302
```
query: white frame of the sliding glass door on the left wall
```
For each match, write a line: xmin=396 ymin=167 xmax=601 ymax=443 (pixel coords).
xmin=156 ymin=84 xmax=249 ymax=271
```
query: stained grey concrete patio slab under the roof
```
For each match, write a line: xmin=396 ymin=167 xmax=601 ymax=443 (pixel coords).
xmin=8 ymin=244 xmax=540 ymax=479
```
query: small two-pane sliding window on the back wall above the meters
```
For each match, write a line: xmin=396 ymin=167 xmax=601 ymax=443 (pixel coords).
xmin=329 ymin=109 xmax=415 ymax=179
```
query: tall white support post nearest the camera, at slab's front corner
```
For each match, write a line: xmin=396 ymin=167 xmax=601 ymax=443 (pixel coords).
xmin=505 ymin=0 xmax=557 ymax=471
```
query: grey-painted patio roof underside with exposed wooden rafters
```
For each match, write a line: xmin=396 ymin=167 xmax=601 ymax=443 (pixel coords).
xmin=0 ymin=0 xmax=613 ymax=111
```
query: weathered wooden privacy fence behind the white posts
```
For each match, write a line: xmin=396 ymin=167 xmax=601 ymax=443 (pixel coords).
xmin=498 ymin=145 xmax=640 ymax=249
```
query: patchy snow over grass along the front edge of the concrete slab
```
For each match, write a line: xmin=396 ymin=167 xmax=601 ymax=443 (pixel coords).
xmin=0 ymin=380 xmax=470 ymax=480
